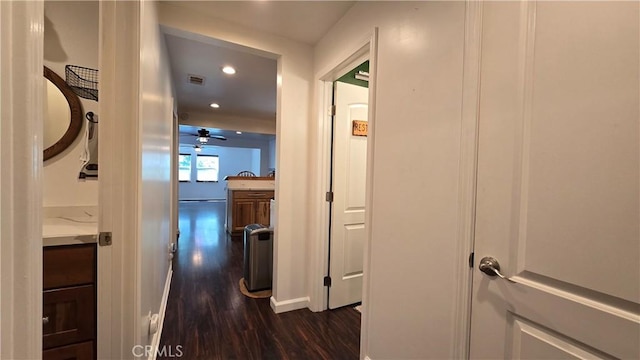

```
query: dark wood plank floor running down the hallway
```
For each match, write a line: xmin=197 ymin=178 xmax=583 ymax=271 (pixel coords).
xmin=160 ymin=202 xmax=360 ymax=359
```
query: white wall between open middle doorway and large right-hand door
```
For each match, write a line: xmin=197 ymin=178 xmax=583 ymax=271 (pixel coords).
xmin=310 ymin=2 xmax=467 ymax=359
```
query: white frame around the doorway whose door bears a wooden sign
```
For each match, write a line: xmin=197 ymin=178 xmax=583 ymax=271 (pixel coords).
xmin=309 ymin=28 xmax=378 ymax=311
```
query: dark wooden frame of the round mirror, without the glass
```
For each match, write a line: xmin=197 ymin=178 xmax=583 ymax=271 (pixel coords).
xmin=43 ymin=66 xmax=83 ymax=161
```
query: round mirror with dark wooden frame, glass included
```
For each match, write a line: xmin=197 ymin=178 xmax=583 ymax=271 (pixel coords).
xmin=43 ymin=66 xmax=82 ymax=160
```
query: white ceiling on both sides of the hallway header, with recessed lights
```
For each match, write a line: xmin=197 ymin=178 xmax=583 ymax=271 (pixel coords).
xmin=162 ymin=1 xmax=355 ymax=135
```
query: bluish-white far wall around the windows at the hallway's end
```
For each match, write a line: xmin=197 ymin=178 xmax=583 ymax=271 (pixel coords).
xmin=178 ymin=145 xmax=261 ymax=200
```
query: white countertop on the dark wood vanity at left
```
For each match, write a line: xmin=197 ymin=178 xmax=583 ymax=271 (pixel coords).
xmin=42 ymin=216 xmax=98 ymax=246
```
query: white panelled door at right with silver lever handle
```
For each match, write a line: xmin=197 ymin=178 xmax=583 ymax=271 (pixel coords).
xmin=470 ymin=2 xmax=640 ymax=359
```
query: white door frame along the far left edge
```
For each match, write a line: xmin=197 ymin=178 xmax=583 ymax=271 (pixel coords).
xmin=0 ymin=0 xmax=44 ymax=359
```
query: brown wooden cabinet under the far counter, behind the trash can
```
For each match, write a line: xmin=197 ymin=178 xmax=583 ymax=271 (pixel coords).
xmin=227 ymin=190 xmax=274 ymax=236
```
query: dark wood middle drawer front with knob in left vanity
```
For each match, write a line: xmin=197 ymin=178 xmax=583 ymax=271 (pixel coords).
xmin=42 ymin=285 xmax=96 ymax=349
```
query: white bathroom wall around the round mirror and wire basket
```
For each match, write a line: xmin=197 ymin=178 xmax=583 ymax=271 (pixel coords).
xmin=43 ymin=1 xmax=100 ymax=207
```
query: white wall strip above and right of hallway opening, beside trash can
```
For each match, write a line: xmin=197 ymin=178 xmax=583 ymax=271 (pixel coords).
xmin=159 ymin=3 xmax=313 ymax=311
